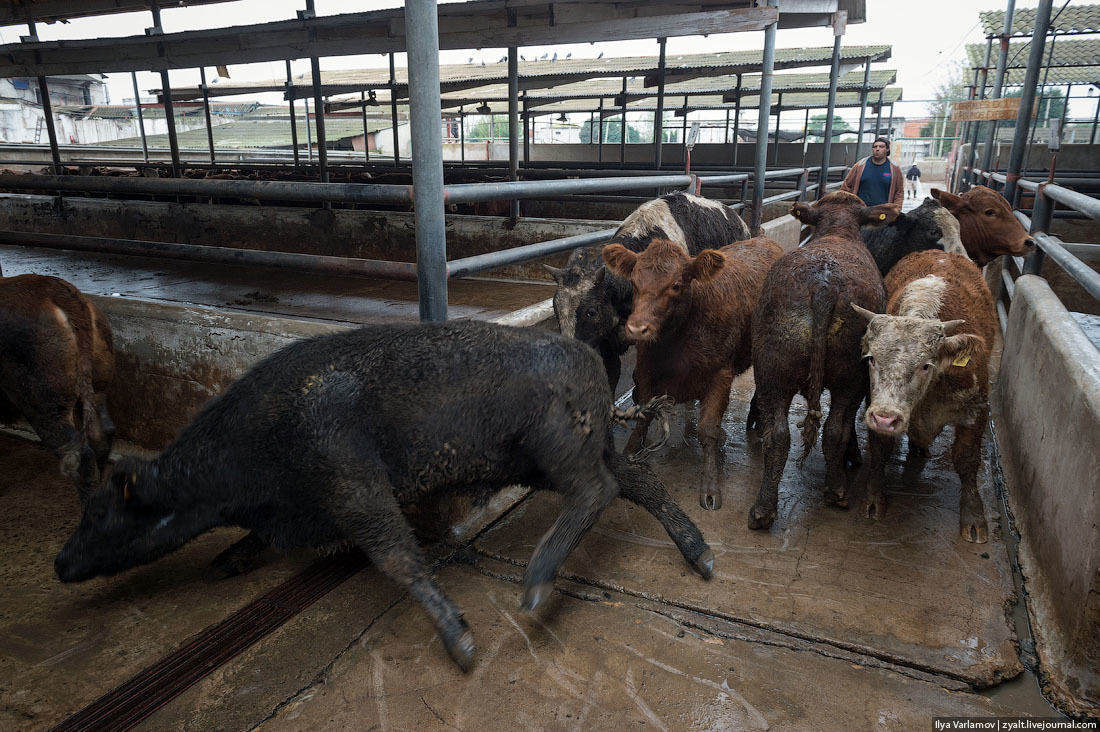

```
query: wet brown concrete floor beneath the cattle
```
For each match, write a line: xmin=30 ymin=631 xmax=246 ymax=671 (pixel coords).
xmin=0 ymin=376 xmax=1053 ymax=731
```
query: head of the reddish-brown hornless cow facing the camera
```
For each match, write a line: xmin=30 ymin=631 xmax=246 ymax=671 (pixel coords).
xmin=604 ymin=239 xmax=726 ymax=342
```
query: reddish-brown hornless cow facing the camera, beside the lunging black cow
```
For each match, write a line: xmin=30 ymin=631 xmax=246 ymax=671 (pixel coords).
xmin=604 ymin=237 xmax=783 ymax=509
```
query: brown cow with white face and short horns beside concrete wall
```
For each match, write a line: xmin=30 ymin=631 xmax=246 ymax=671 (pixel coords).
xmin=854 ymin=251 xmax=997 ymax=544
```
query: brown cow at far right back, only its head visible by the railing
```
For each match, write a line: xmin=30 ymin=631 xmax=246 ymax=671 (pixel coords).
xmin=932 ymin=186 xmax=1035 ymax=266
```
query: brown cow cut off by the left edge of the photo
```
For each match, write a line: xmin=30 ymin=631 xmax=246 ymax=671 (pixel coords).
xmin=0 ymin=274 xmax=114 ymax=502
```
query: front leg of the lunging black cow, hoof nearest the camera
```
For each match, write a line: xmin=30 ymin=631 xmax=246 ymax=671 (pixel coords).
xmin=336 ymin=476 xmax=474 ymax=671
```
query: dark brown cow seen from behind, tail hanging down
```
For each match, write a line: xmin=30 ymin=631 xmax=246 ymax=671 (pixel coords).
xmin=749 ymin=192 xmax=898 ymax=528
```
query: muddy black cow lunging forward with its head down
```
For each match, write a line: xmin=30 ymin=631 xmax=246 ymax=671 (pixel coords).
xmin=55 ymin=321 xmax=714 ymax=669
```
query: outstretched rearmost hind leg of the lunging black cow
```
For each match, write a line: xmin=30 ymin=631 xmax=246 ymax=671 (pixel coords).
xmin=608 ymin=452 xmax=714 ymax=579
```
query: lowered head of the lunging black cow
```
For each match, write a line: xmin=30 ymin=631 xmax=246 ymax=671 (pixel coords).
xmin=54 ymin=459 xmax=200 ymax=582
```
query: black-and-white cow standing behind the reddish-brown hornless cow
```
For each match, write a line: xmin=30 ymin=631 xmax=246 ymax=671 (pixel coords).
xmin=547 ymin=192 xmax=749 ymax=389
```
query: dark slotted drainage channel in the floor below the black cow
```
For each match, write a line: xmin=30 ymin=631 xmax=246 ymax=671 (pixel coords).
xmin=51 ymin=551 xmax=367 ymax=732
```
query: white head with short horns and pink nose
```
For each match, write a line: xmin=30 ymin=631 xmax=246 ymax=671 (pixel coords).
xmin=851 ymin=304 xmax=986 ymax=437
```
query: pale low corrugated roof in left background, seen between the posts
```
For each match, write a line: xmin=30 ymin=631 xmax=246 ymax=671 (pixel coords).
xmin=99 ymin=117 xmax=392 ymax=150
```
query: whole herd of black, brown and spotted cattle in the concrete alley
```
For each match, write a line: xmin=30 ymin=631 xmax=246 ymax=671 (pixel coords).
xmin=0 ymin=181 xmax=1031 ymax=669
